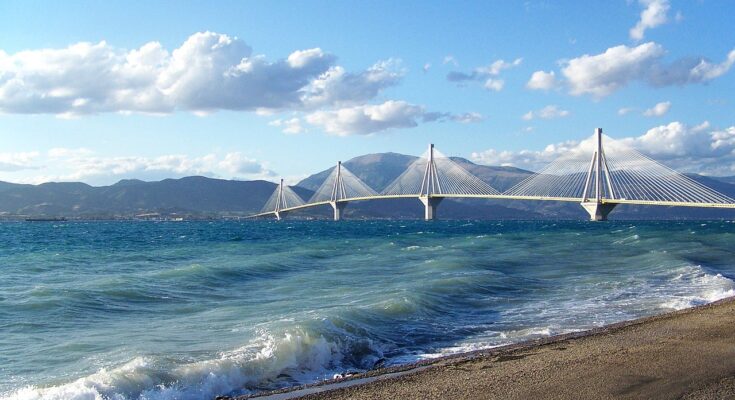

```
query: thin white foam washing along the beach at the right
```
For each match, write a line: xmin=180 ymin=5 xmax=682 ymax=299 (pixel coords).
xmin=418 ymin=265 xmax=735 ymax=359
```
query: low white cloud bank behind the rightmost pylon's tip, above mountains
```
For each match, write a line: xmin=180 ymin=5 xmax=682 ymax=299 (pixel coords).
xmin=471 ymin=121 xmax=735 ymax=176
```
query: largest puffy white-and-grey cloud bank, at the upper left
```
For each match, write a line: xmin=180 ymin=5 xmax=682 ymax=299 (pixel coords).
xmin=0 ymin=32 xmax=402 ymax=116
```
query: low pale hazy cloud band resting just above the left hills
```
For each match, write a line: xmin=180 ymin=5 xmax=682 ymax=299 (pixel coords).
xmin=0 ymin=148 xmax=276 ymax=185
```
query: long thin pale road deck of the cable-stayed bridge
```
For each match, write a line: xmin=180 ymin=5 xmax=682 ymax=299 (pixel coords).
xmin=246 ymin=194 xmax=735 ymax=218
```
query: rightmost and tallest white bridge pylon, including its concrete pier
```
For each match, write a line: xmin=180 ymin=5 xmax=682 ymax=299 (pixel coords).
xmin=580 ymin=128 xmax=616 ymax=221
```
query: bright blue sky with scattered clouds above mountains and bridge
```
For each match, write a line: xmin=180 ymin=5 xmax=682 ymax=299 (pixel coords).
xmin=0 ymin=0 xmax=735 ymax=186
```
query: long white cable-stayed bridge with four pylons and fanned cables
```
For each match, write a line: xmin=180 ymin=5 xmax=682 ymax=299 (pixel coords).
xmin=250 ymin=128 xmax=735 ymax=221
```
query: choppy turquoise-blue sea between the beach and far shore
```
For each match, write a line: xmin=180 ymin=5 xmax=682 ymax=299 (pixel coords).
xmin=0 ymin=221 xmax=735 ymax=399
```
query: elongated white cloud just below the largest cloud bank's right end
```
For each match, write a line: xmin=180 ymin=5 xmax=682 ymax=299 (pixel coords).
xmin=306 ymin=100 xmax=427 ymax=136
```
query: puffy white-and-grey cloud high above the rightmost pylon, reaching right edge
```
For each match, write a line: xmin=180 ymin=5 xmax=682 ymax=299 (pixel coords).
xmin=561 ymin=42 xmax=735 ymax=98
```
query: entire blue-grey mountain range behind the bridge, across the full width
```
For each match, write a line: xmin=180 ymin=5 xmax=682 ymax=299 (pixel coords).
xmin=0 ymin=153 xmax=735 ymax=219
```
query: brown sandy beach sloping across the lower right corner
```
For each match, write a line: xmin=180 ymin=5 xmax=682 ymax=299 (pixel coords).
xmin=242 ymin=298 xmax=735 ymax=400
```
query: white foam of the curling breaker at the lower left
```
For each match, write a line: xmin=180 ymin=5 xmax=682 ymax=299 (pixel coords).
xmin=3 ymin=331 xmax=374 ymax=400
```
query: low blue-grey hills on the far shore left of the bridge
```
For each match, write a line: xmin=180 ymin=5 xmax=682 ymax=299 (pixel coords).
xmin=0 ymin=176 xmax=311 ymax=218
